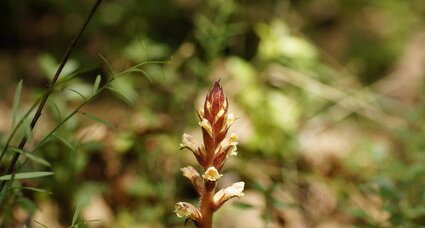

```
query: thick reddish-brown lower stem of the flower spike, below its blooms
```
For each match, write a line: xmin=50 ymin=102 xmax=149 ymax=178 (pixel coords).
xmin=198 ymin=180 xmax=216 ymax=228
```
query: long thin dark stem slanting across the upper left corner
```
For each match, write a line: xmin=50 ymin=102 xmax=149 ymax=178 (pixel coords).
xmin=0 ymin=0 xmax=102 ymax=192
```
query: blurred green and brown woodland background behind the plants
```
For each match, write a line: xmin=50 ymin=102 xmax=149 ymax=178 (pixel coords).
xmin=0 ymin=0 xmax=425 ymax=228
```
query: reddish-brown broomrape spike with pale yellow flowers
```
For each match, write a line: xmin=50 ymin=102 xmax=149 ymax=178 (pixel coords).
xmin=175 ymin=81 xmax=245 ymax=228
